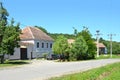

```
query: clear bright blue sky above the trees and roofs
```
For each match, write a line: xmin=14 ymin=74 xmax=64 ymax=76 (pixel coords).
xmin=0 ymin=0 xmax=120 ymax=42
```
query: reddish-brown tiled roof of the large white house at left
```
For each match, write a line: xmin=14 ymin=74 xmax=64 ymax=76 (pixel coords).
xmin=20 ymin=27 xmax=53 ymax=41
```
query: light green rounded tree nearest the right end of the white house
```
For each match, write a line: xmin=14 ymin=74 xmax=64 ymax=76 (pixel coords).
xmin=52 ymin=35 xmax=68 ymax=59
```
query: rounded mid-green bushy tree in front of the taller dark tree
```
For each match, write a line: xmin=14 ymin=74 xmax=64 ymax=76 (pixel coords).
xmin=70 ymin=36 xmax=88 ymax=60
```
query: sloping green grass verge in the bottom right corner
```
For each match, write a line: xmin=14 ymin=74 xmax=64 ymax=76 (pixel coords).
xmin=49 ymin=62 xmax=120 ymax=80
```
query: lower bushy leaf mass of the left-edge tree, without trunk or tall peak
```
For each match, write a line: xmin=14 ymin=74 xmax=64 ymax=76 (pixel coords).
xmin=1 ymin=20 xmax=21 ymax=54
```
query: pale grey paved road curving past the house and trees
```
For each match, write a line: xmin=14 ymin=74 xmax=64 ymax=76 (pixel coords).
xmin=0 ymin=59 xmax=120 ymax=80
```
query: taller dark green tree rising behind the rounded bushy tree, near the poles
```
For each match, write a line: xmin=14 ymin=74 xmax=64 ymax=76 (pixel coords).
xmin=77 ymin=27 xmax=96 ymax=58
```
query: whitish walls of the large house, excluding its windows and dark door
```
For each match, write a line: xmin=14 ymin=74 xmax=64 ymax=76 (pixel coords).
xmin=7 ymin=40 xmax=53 ymax=59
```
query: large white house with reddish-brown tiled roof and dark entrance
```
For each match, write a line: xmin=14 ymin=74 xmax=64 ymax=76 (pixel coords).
xmin=5 ymin=27 xmax=54 ymax=59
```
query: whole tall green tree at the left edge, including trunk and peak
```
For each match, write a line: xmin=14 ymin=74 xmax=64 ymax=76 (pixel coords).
xmin=0 ymin=3 xmax=21 ymax=63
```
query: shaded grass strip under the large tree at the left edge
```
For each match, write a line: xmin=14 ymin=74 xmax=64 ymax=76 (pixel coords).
xmin=0 ymin=60 xmax=30 ymax=68
